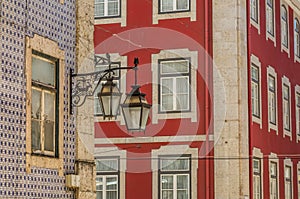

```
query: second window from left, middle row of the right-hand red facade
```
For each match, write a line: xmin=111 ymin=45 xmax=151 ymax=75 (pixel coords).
xmin=268 ymin=75 xmax=276 ymax=125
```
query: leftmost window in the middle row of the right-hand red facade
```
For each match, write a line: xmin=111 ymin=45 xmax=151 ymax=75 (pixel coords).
xmin=251 ymin=64 xmax=260 ymax=118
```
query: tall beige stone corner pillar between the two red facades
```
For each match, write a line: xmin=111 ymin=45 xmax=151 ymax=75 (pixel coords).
xmin=212 ymin=0 xmax=250 ymax=199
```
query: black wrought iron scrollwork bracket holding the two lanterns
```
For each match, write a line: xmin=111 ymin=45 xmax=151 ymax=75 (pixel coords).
xmin=69 ymin=54 xmax=138 ymax=113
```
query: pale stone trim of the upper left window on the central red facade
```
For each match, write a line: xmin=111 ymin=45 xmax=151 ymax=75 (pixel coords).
xmin=94 ymin=0 xmax=127 ymax=27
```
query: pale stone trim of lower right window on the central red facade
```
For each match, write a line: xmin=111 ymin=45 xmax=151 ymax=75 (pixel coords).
xmin=151 ymin=145 xmax=198 ymax=199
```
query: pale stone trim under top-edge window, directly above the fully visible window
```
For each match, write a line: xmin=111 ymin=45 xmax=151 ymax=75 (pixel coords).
xmin=152 ymin=0 xmax=197 ymax=24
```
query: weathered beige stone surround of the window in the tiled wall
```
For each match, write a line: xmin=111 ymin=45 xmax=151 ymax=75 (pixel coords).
xmin=26 ymin=34 xmax=65 ymax=176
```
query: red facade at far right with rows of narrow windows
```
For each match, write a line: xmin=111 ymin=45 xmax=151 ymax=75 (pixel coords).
xmin=248 ymin=0 xmax=300 ymax=199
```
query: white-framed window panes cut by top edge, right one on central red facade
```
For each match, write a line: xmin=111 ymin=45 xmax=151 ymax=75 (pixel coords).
xmin=160 ymin=0 xmax=190 ymax=13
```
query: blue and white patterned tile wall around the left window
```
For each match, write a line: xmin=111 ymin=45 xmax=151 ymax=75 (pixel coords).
xmin=0 ymin=0 xmax=76 ymax=198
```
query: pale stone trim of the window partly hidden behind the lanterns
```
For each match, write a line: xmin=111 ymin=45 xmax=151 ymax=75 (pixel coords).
xmin=95 ymin=53 xmax=127 ymax=125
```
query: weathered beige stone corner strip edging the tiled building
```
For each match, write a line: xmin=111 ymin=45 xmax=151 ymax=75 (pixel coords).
xmin=74 ymin=0 xmax=96 ymax=199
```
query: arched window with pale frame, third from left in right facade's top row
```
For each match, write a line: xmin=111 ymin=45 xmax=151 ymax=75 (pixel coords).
xmin=280 ymin=3 xmax=290 ymax=57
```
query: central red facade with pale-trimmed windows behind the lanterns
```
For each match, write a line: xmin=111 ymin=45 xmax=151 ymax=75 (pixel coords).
xmin=94 ymin=0 xmax=214 ymax=199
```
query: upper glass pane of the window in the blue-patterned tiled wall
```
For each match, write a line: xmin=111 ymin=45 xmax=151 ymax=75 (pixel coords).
xmin=32 ymin=57 xmax=55 ymax=86
